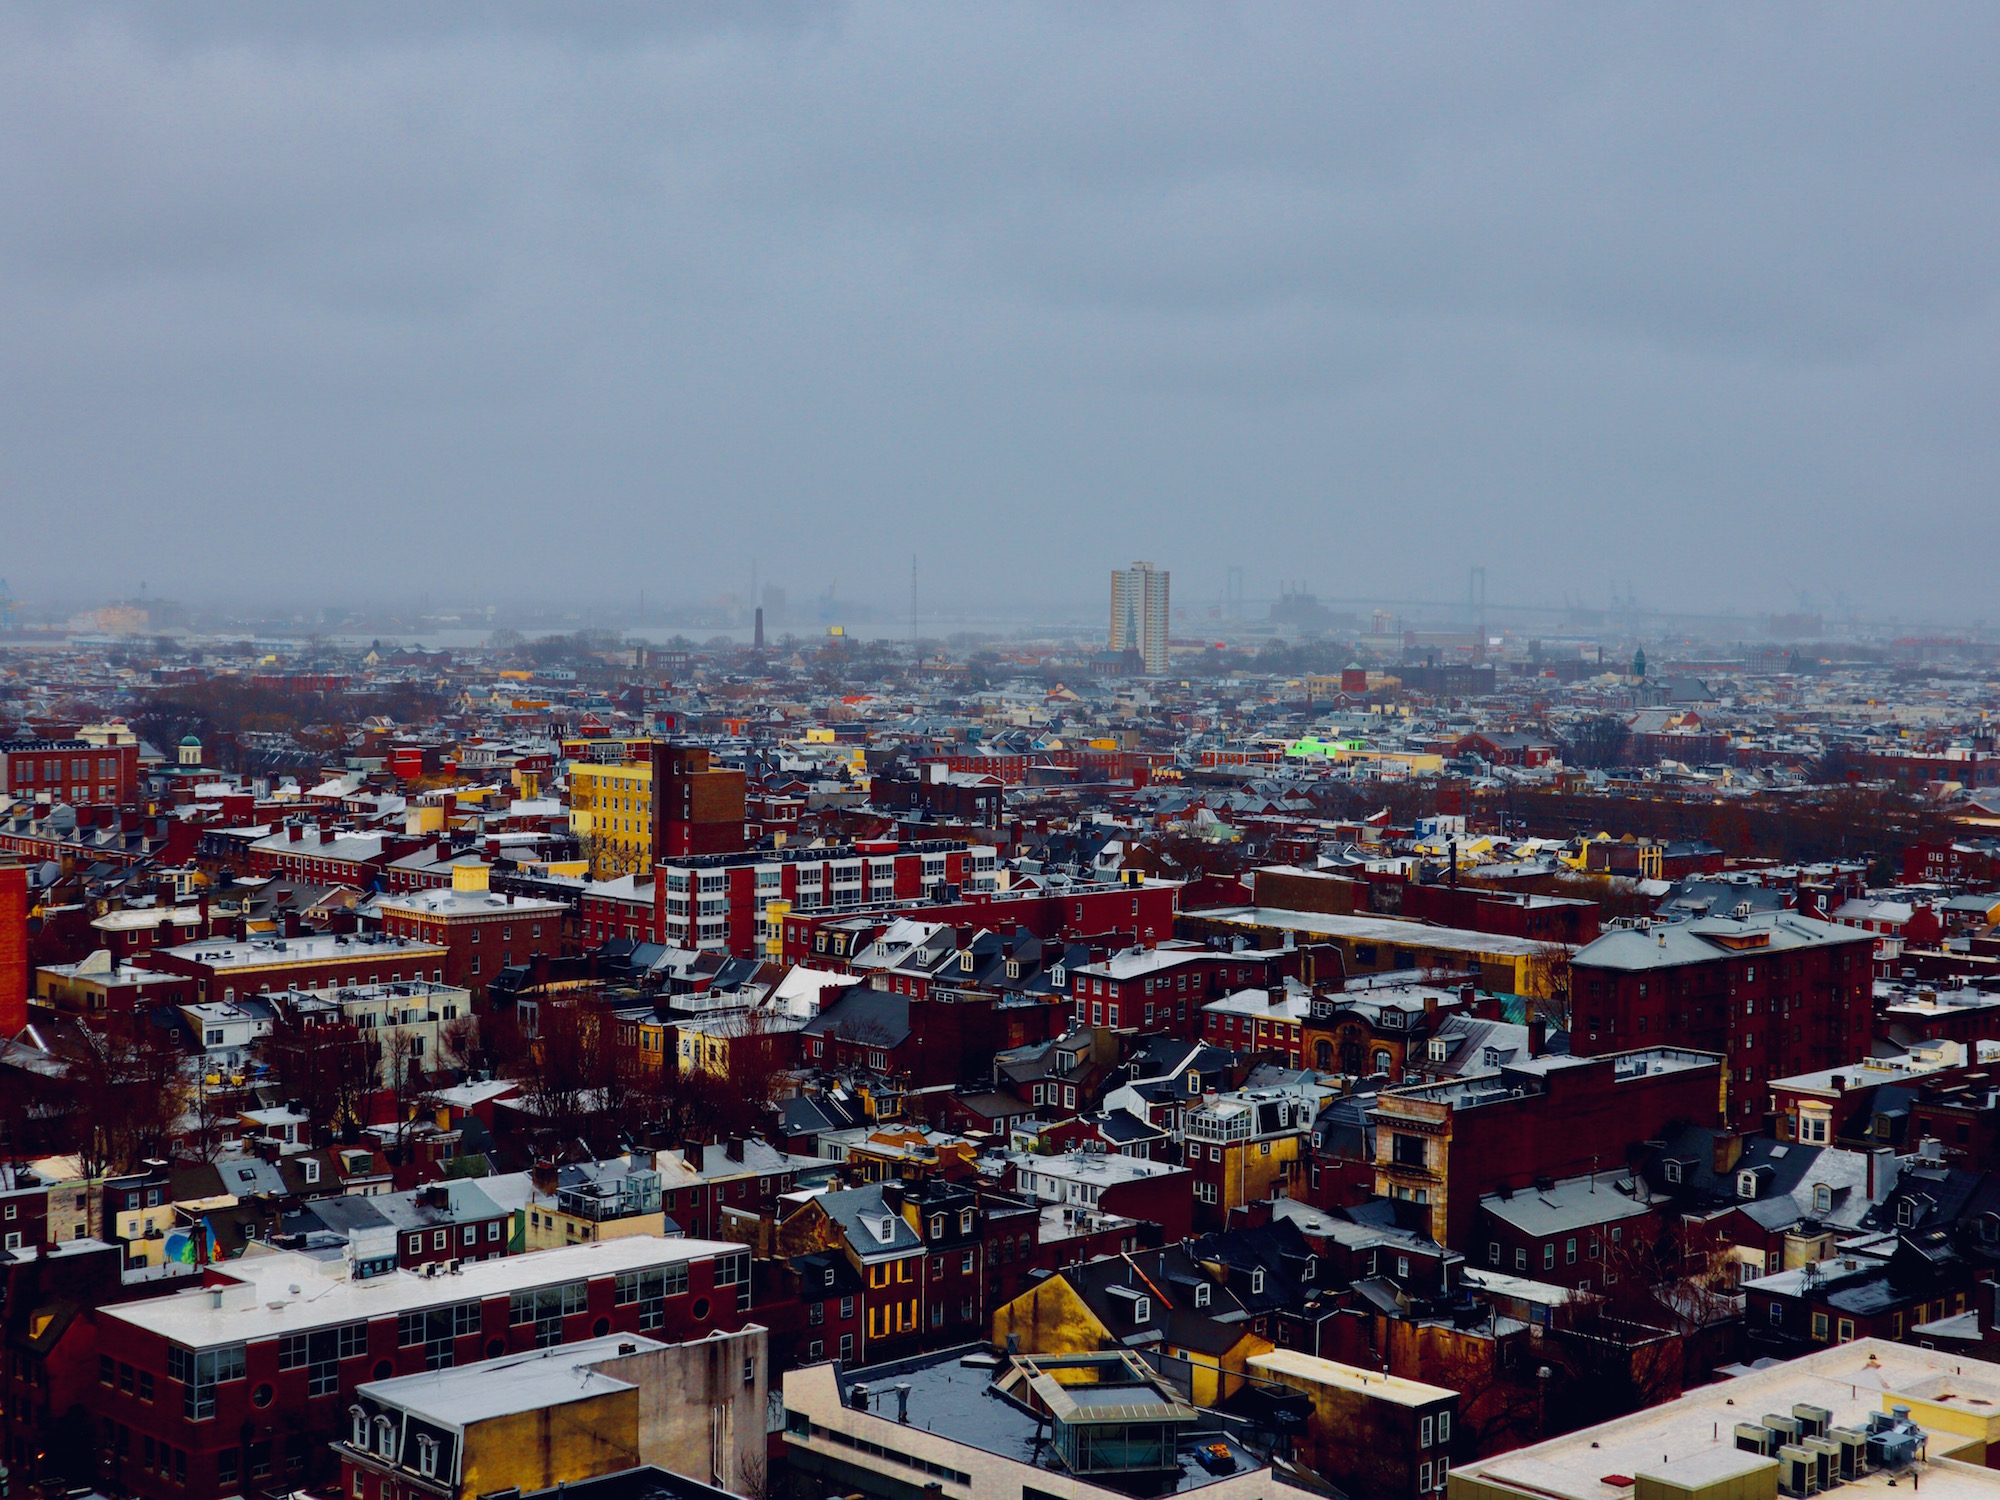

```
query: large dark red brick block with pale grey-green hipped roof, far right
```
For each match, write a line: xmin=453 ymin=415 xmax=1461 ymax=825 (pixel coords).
xmin=1570 ymin=912 xmax=1874 ymax=1124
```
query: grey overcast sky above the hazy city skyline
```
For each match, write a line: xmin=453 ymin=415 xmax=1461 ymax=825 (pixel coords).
xmin=0 ymin=0 xmax=2000 ymax=618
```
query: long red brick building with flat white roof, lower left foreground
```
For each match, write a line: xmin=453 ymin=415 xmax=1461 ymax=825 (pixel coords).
xmin=72 ymin=1236 xmax=750 ymax=1500
